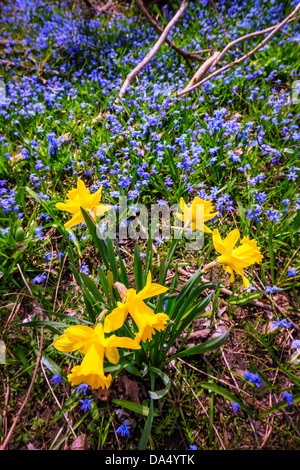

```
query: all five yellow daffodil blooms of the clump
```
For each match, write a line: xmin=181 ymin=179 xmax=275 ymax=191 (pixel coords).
xmin=53 ymin=180 xmax=262 ymax=389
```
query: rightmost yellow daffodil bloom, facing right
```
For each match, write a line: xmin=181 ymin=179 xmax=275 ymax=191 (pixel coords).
xmin=212 ymin=229 xmax=263 ymax=289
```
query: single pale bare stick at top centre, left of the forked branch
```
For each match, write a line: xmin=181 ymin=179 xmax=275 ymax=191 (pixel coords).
xmin=118 ymin=0 xmax=188 ymax=98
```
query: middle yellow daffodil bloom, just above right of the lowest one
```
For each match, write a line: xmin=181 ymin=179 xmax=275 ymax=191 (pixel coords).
xmin=104 ymin=273 xmax=169 ymax=343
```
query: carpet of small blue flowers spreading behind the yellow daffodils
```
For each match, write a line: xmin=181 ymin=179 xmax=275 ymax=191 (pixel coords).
xmin=0 ymin=0 xmax=300 ymax=444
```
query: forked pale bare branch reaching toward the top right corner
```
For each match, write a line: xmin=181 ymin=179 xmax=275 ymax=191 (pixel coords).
xmin=177 ymin=3 xmax=300 ymax=97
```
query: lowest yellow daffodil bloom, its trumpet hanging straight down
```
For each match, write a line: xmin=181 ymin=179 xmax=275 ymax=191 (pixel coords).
xmin=53 ymin=322 xmax=140 ymax=389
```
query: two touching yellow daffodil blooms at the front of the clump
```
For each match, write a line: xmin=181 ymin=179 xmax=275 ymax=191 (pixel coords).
xmin=53 ymin=273 xmax=169 ymax=389
